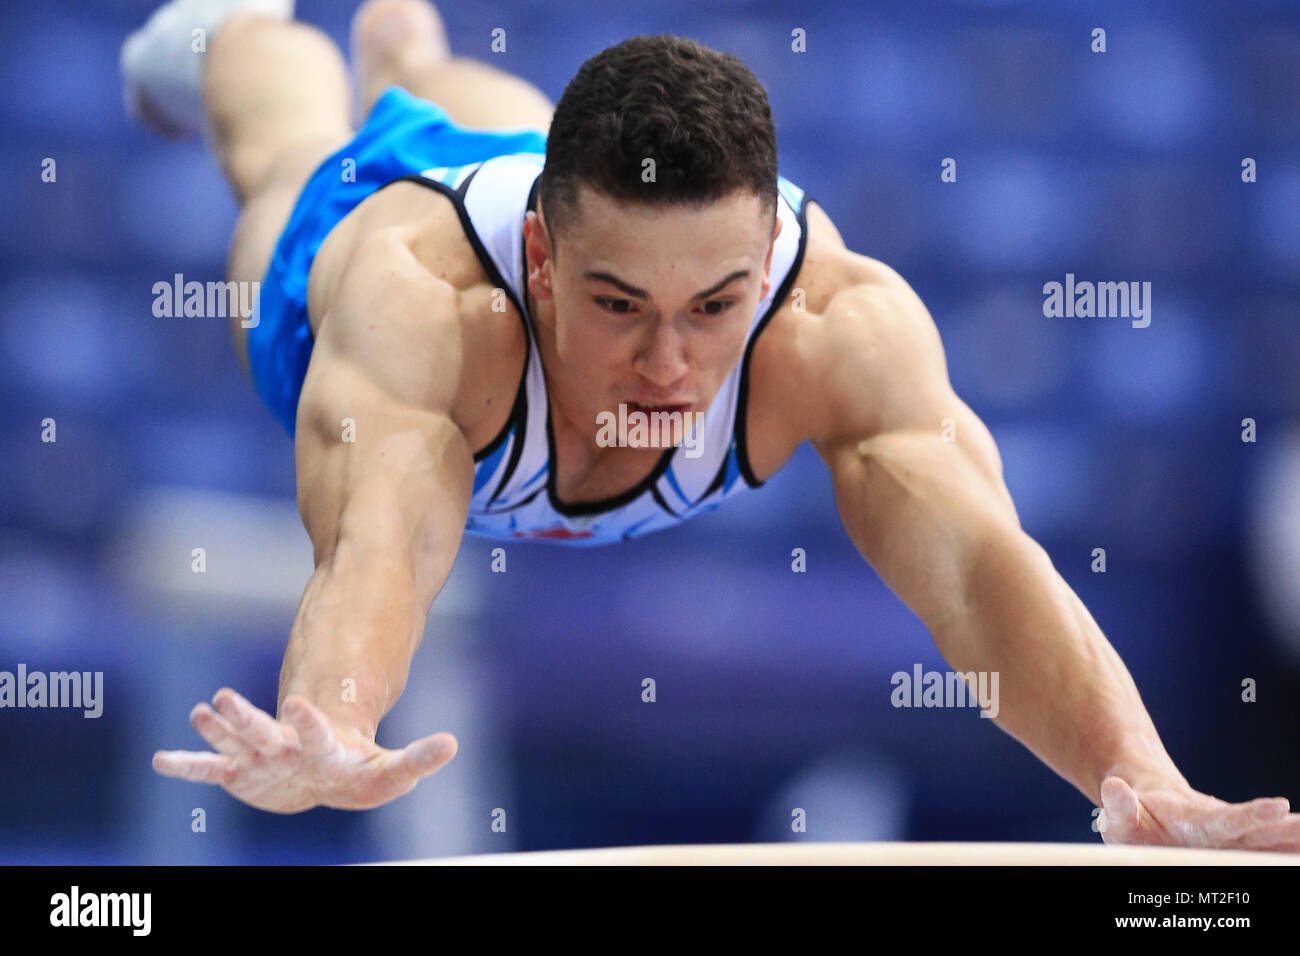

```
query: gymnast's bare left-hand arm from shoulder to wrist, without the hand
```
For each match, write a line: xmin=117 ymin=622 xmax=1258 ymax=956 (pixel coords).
xmin=280 ymin=237 xmax=473 ymax=739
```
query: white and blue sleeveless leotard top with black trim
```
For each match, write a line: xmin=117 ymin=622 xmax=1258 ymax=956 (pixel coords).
xmin=406 ymin=153 xmax=807 ymax=545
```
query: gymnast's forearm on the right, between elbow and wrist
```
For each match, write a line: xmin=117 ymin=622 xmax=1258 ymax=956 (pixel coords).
xmin=933 ymin=528 xmax=1187 ymax=805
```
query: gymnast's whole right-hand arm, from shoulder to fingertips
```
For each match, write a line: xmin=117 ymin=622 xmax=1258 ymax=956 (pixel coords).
xmin=813 ymin=264 xmax=1300 ymax=849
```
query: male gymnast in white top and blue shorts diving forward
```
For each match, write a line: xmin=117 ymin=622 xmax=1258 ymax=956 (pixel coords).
xmin=122 ymin=0 xmax=1300 ymax=852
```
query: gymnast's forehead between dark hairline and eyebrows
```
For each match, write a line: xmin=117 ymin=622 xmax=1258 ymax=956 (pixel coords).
xmin=560 ymin=186 xmax=772 ymax=274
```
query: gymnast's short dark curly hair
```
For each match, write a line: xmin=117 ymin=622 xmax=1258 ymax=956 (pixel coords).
xmin=541 ymin=34 xmax=777 ymax=247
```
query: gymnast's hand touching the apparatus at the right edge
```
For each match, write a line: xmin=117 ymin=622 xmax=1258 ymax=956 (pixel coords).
xmin=1099 ymin=777 xmax=1300 ymax=853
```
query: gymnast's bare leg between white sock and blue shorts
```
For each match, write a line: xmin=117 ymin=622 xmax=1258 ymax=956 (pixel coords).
xmin=203 ymin=13 xmax=352 ymax=371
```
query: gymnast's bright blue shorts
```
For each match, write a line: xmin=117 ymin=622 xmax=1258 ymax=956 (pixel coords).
xmin=246 ymin=86 xmax=546 ymax=434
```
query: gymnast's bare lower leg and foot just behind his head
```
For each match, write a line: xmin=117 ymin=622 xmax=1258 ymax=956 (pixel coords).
xmin=352 ymin=0 xmax=555 ymax=130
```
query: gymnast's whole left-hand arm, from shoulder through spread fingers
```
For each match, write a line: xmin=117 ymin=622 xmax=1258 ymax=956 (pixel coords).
xmin=155 ymin=233 xmax=473 ymax=813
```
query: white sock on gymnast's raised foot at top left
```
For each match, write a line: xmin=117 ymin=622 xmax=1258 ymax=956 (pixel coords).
xmin=121 ymin=0 xmax=294 ymax=135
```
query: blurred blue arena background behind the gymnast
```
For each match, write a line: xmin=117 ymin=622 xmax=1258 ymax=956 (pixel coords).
xmin=0 ymin=0 xmax=1300 ymax=864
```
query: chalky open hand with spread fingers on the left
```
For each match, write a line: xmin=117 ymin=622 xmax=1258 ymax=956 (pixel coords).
xmin=153 ymin=687 xmax=456 ymax=813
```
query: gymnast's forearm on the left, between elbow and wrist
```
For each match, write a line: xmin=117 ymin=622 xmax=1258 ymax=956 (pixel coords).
xmin=278 ymin=540 xmax=428 ymax=740
